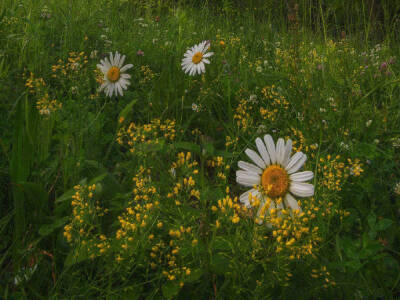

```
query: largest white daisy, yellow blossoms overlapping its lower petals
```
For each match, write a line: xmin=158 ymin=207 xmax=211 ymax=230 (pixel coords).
xmin=236 ymin=134 xmax=314 ymax=224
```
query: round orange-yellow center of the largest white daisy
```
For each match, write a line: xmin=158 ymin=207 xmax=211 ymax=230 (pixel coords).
xmin=261 ymin=165 xmax=289 ymax=198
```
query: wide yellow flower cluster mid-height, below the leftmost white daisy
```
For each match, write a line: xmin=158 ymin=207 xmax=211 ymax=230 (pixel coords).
xmin=117 ymin=119 xmax=176 ymax=153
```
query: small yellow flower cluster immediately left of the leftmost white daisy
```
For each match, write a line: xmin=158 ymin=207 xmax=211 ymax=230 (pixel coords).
xmin=51 ymin=51 xmax=88 ymax=78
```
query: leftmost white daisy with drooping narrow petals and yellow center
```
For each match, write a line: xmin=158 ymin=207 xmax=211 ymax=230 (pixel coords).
xmin=97 ymin=52 xmax=133 ymax=97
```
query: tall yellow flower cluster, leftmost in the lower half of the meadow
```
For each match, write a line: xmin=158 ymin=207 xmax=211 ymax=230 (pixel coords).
xmin=64 ymin=184 xmax=110 ymax=258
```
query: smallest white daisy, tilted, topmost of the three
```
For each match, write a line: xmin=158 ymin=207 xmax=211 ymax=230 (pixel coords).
xmin=181 ymin=41 xmax=214 ymax=76
